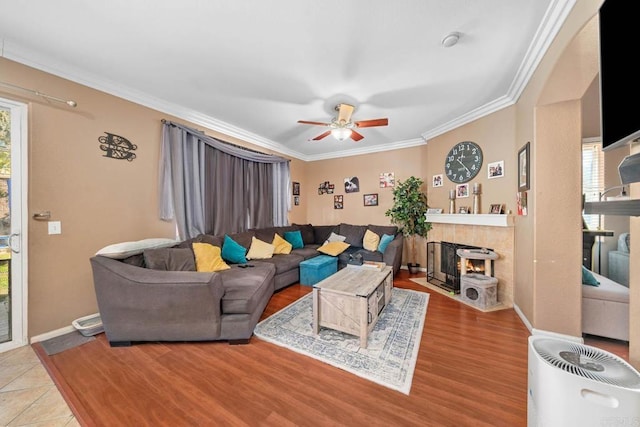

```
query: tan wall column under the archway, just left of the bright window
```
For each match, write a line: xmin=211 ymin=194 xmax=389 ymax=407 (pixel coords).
xmin=529 ymin=101 xmax=582 ymax=336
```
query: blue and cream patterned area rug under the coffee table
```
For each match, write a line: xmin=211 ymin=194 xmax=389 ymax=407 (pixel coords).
xmin=254 ymin=288 xmax=429 ymax=394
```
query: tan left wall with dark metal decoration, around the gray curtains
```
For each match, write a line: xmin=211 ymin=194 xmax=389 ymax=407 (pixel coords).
xmin=0 ymin=58 xmax=306 ymax=337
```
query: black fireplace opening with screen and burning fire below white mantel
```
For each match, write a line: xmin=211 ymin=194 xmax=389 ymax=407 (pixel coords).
xmin=427 ymin=242 xmax=493 ymax=294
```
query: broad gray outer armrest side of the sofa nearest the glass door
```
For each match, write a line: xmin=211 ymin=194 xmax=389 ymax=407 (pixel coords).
xmin=90 ymin=256 xmax=224 ymax=342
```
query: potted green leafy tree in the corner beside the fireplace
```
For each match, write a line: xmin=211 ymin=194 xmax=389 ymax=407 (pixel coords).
xmin=385 ymin=176 xmax=431 ymax=274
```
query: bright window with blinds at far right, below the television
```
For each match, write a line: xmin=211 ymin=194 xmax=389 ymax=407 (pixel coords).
xmin=582 ymin=141 xmax=604 ymax=230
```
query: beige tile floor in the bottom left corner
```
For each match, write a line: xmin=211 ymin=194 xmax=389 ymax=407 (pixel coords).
xmin=0 ymin=346 xmax=80 ymax=427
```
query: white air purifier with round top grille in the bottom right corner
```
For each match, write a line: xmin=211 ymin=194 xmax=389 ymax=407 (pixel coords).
xmin=527 ymin=336 xmax=640 ymax=427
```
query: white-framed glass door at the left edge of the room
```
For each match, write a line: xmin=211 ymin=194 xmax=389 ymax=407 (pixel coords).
xmin=0 ymin=98 xmax=27 ymax=352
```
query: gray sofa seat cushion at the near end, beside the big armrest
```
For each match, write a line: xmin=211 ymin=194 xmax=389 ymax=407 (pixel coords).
xmin=219 ymin=262 xmax=275 ymax=314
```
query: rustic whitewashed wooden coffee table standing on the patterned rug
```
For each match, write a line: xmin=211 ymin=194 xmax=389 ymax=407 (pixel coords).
xmin=313 ymin=266 xmax=393 ymax=348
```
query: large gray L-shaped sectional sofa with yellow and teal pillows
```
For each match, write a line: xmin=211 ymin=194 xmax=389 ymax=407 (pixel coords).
xmin=90 ymin=224 xmax=403 ymax=346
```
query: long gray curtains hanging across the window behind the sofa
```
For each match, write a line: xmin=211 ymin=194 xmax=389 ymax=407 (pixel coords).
xmin=159 ymin=121 xmax=290 ymax=239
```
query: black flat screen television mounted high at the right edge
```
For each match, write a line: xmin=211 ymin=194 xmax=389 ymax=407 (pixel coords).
xmin=599 ymin=0 xmax=640 ymax=150
